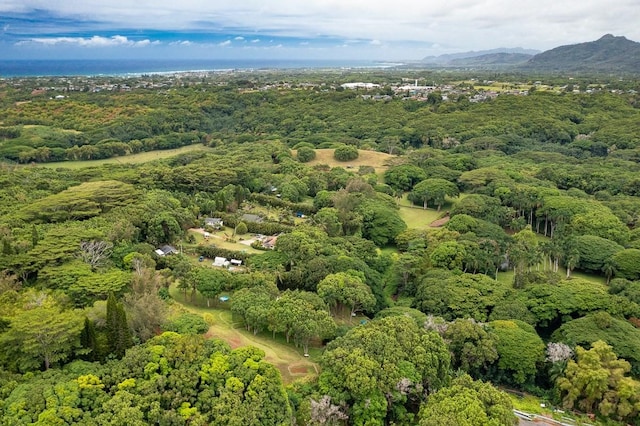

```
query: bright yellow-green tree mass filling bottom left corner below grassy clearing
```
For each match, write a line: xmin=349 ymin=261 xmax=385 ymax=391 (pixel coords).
xmin=0 ymin=333 xmax=291 ymax=425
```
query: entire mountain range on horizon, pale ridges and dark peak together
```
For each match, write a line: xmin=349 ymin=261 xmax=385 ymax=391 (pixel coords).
xmin=421 ymin=34 xmax=640 ymax=74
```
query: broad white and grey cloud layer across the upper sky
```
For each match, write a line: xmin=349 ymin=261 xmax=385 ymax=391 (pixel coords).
xmin=5 ymin=0 xmax=640 ymax=57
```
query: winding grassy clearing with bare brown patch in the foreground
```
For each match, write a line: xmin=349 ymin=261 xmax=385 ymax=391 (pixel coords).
xmin=169 ymin=285 xmax=321 ymax=383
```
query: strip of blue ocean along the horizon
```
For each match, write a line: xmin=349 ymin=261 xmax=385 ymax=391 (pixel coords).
xmin=0 ymin=59 xmax=400 ymax=78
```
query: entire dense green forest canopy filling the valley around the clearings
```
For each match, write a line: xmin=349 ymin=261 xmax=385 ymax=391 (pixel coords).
xmin=0 ymin=73 xmax=640 ymax=424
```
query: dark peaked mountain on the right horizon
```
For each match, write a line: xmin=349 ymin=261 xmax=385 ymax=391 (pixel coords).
xmin=522 ymin=34 xmax=640 ymax=74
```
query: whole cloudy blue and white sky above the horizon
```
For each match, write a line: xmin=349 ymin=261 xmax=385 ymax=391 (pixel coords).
xmin=0 ymin=0 xmax=640 ymax=61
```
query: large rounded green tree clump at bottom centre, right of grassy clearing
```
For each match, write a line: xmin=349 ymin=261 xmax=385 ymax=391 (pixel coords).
xmin=319 ymin=316 xmax=450 ymax=424
